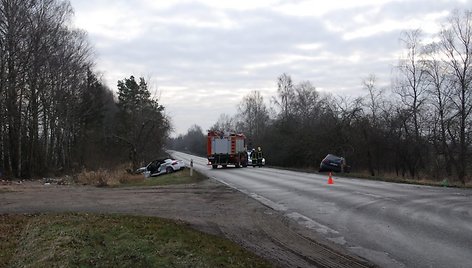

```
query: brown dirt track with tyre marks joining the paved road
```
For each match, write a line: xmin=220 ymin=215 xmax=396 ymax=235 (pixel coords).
xmin=0 ymin=179 xmax=374 ymax=267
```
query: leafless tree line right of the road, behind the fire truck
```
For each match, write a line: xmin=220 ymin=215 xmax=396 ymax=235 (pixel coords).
xmin=173 ymin=10 xmax=472 ymax=183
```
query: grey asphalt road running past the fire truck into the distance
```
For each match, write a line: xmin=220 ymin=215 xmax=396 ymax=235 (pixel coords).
xmin=172 ymin=152 xmax=472 ymax=267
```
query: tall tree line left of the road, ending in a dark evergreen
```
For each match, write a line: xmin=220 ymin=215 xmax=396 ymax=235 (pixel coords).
xmin=0 ymin=0 xmax=170 ymax=178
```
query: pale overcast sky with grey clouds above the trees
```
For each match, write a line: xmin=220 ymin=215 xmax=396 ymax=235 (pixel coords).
xmin=70 ymin=0 xmax=472 ymax=135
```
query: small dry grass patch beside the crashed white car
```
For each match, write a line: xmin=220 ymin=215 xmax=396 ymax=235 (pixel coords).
xmin=119 ymin=168 xmax=207 ymax=187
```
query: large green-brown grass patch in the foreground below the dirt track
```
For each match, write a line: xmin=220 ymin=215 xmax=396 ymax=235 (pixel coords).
xmin=0 ymin=213 xmax=271 ymax=267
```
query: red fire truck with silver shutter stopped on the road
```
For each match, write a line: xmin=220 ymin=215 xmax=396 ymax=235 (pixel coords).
xmin=207 ymin=131 xmax=248 ymax=168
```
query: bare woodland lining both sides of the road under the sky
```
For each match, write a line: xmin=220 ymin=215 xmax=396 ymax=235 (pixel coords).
xmin=0 ymin=0 xmax=472 ymax=183
